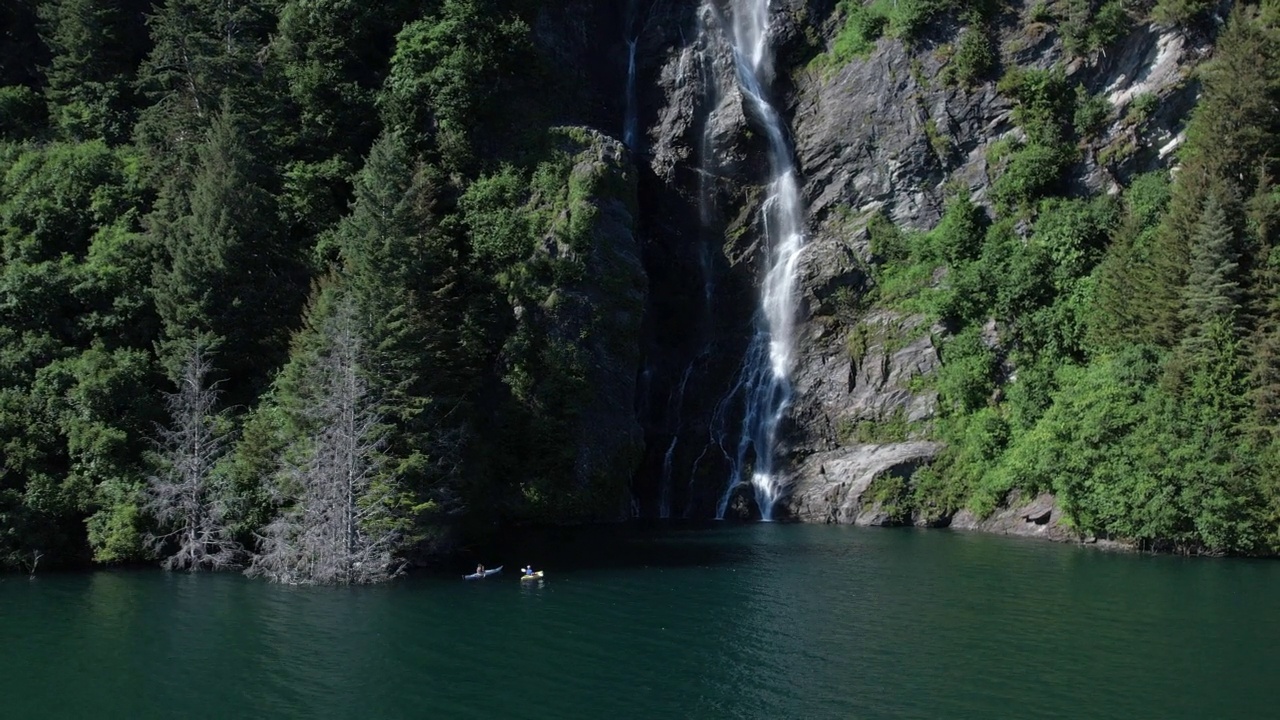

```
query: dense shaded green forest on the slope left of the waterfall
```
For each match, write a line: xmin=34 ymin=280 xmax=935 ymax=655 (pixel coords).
xmin=0 ymin=0 xmax=643 ymax=573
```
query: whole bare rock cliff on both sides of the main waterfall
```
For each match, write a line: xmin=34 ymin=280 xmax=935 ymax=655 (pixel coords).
xmin=614 ymin=0 xmax=1210 ymax=534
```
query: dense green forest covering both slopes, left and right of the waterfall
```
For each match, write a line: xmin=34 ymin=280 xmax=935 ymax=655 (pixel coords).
xmin=0 ymin=0 xmax=1280 ymax=573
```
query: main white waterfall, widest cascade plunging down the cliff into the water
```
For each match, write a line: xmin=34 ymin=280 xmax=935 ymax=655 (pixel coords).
xmin=717 ymin=0 xmax=804 ymax=520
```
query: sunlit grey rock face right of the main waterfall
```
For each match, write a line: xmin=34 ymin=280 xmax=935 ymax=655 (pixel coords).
xmin=778 ymin=0 xmax=1208 ymax=525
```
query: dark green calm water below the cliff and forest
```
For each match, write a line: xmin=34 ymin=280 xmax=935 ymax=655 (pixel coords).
xmin=0 ymin=524 xmax=1280 ymax=719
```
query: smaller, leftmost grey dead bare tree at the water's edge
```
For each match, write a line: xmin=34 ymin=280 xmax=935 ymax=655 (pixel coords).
xmin=147 ymin=345 xmax=241 ymax=570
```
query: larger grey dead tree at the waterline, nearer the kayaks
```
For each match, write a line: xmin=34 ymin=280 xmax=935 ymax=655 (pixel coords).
xmin=248 ymin=300 xmax=404 ymax=584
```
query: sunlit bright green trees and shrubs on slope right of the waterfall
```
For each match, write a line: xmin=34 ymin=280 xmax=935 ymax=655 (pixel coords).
xmin=844 ymin=3 xmax=1280 ymax=553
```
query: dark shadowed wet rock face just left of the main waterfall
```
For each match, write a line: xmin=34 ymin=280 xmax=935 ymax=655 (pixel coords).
xmin=624 ymin=0 xmax=768 ymax=516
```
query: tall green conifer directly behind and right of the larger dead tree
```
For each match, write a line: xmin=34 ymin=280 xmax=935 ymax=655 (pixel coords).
xmin=338 ymin=133 xmax=474 ymax=515
